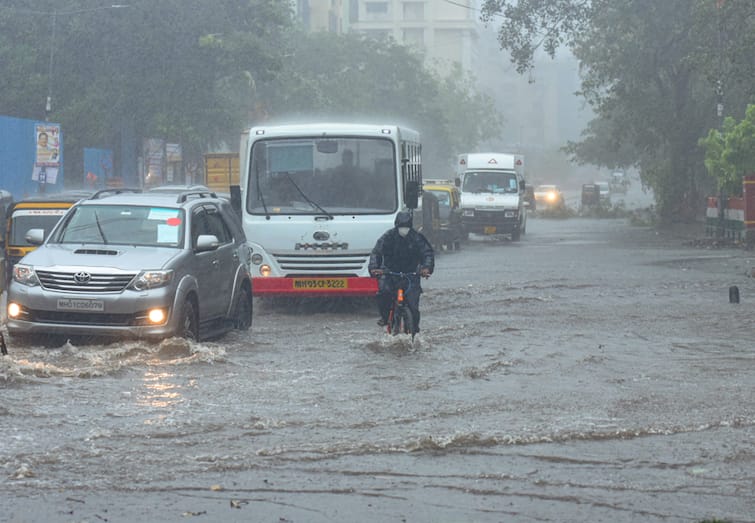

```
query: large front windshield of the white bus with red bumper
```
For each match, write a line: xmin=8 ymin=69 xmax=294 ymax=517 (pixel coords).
xmin=247 ymin=137 xmax=398 ymax=215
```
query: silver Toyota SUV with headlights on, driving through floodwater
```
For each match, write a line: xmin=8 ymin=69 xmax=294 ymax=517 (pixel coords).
xmin=7 ymin=189 xmax=252 ymax=340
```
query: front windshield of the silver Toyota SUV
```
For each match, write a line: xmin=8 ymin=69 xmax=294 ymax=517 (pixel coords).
xmin=50 ymin=205 xmax=185 ymax=248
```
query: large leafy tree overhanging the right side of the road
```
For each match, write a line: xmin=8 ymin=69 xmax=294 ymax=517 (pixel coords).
xmin=484 ymin=0 xmax=755 ymax=220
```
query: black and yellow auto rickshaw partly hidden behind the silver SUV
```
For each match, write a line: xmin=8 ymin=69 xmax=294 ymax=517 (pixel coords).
xmin=3 ymin=191 xmax=91 ymax=285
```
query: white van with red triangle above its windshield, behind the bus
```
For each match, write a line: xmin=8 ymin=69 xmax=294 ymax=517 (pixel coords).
xmin=456 ymin=153 xmax=527 ymax=241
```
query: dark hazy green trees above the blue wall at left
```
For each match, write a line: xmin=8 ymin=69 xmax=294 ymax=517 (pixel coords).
xmin=0 ymin=0 xmax=293 ymax=187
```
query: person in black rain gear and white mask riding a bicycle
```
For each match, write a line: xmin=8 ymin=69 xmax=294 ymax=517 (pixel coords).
xmin=368 ymin=211 xmax=435 ymax=332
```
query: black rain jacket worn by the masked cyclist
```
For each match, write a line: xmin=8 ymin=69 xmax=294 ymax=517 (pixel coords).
xmin=369 ymin=227 xmax=435 ymax=273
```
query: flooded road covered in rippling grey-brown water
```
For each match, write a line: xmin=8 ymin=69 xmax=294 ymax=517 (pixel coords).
xmin=0 ymin=218 xmax=755 ymax=523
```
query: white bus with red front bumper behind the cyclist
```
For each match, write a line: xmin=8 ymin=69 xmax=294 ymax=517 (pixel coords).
xmin=240 ymin=123 xmax=422 ymax=296
